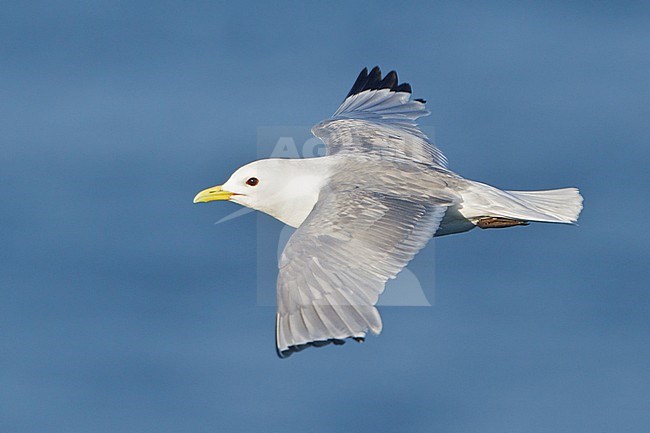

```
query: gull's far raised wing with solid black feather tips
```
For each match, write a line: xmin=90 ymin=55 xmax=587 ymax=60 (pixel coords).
xmin=312 ymin=67 xmax=447 ymax=167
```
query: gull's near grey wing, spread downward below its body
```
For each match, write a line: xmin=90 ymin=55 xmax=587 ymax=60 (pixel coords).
xmin=276 ymin=184 xmax=451 ymax=357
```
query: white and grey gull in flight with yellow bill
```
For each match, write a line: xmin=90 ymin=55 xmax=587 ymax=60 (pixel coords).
xmin=194 ymin=67 xmax=582 ymax=358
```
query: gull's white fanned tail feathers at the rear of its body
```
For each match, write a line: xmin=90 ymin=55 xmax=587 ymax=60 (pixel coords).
xmin=460 ymin=182 xmax=582 ymax=223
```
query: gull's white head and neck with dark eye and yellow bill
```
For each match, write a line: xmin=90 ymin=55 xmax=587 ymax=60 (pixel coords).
xmin=194 ymin=158 xmax=327 ymax=227
